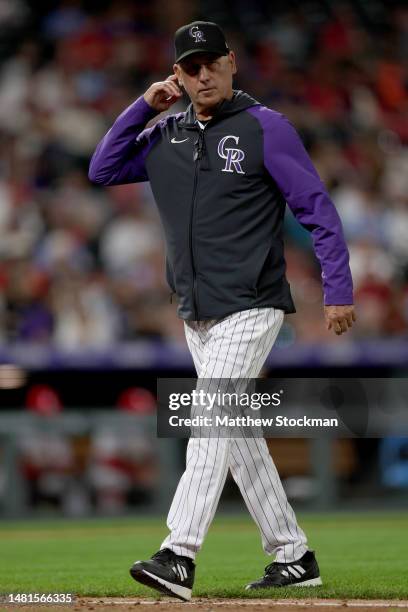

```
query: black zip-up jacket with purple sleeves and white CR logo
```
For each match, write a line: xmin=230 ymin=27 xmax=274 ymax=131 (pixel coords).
xmin=89 ymin=91 xmax=353 ymax=320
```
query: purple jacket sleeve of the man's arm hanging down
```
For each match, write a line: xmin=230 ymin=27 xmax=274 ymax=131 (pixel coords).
xmin=249 ymin=106 xmax=353 ymax=306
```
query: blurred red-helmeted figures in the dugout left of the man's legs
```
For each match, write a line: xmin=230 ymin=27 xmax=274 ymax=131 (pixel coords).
xmin=0 ymin=384 xmax=159 ymax=516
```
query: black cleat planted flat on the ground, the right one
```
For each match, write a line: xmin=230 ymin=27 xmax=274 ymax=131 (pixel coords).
xmin=245 ymin=550 xmax=322 ymax=590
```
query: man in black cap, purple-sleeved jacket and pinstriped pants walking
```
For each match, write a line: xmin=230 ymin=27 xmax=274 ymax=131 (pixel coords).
xmin=89 ymin=21 xmax=355 ymax=600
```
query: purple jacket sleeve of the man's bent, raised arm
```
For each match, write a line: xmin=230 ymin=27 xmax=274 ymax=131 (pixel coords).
xmin=88 ymin=96 xmax=158 ymax=185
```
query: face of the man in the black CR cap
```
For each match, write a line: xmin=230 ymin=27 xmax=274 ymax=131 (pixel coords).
xmin=173 ymin=51 xmax=237 ymax=109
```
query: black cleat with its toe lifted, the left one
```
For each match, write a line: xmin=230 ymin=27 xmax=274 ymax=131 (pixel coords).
xmin=130 ymin=548 xmax=195 ymax=601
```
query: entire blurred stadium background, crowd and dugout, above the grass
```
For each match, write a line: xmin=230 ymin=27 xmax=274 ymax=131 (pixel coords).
xmin=0 ymin=0 xmax=408 ymax=515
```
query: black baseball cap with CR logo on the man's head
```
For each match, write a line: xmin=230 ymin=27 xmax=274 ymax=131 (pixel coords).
xmin=174 ymin=21 xmax=229 ymax=63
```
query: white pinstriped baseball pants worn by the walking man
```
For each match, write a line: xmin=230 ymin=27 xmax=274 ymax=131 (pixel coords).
xmin=161 ymin=308 xmax=307 ymax=563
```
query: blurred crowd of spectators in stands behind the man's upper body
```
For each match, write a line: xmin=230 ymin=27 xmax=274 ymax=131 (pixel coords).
xmin=0 ymin=0 xmax=408 ymax=349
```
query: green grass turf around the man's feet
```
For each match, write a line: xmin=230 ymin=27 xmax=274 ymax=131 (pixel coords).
xmin=0 ymin=514 xmax=408 ymax=599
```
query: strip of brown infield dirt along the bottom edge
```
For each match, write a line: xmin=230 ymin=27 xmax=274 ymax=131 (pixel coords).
xmin=1 ymin=597 xmax=408 ymax=612
